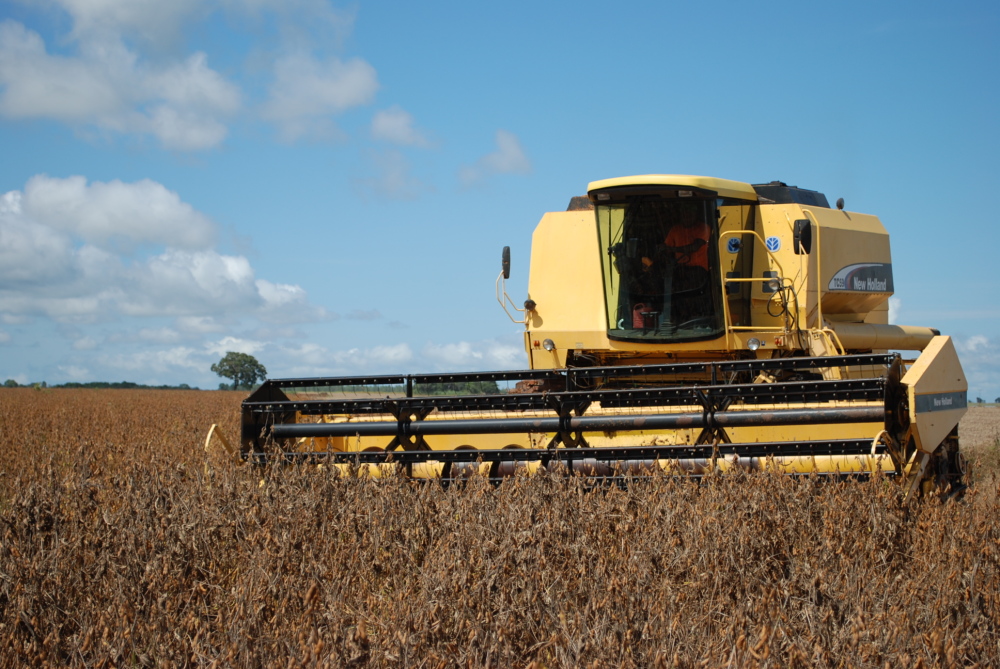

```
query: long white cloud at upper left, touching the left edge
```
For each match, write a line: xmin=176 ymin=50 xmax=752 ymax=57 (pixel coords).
xmin=0 ymin=19 xmax=241 ymax=150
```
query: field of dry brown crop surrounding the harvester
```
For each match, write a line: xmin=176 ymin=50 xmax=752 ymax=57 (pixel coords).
xmin=0 ymin=389 xmax=1000 ymax=667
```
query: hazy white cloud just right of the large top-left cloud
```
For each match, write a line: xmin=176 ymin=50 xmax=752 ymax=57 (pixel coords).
xmin=261 ymin=53 xmax=378 ymax=142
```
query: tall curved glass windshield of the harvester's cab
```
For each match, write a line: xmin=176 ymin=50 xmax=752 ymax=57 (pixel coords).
xmin=595 ymin=190 xmax=725 ymax=341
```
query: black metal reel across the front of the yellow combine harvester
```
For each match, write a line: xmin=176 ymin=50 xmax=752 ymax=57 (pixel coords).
xmin=242 ymin=354 xmax=899 ymax=465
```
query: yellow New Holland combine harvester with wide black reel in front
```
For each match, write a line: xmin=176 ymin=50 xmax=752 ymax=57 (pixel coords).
xmin=241 ymin=175 xmax=967 ymax=494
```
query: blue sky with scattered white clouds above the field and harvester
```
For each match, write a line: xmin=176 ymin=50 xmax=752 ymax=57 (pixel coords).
xmin=0 ymin=0 xmax=1000 ymax=400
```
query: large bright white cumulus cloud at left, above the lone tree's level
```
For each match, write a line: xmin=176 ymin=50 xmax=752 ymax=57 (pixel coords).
xmin=0 ymin=176 xmax=328 ymax=324
